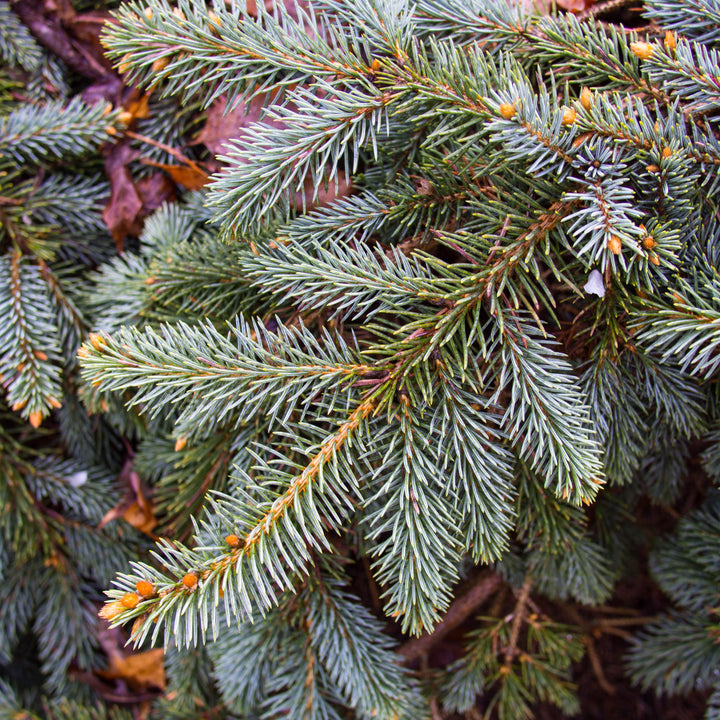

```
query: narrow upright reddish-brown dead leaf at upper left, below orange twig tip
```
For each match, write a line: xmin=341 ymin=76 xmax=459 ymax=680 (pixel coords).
xmin=103 ymin=142 xmax=143 ymax=252
